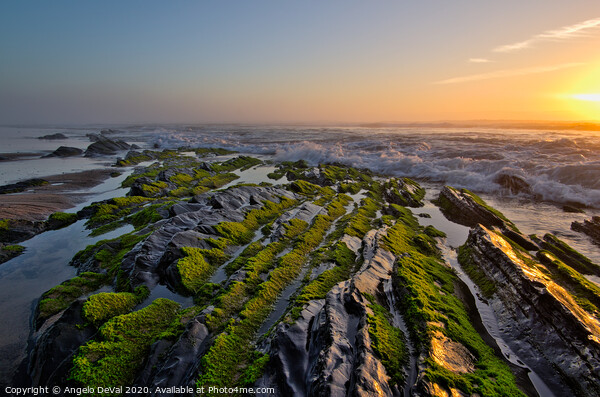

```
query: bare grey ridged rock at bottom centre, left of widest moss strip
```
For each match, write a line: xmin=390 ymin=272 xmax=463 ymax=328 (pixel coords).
xmin=257 ymin=231 xmax=399 ymax=396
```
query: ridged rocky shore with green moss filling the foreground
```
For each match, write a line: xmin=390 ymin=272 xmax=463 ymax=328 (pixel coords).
xmin=1 ymin=148 xmax=600 ymax=396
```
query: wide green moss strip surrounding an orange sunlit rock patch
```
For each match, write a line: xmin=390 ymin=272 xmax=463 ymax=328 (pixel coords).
xmin=384 ymin=213 xmax=524 ymax=396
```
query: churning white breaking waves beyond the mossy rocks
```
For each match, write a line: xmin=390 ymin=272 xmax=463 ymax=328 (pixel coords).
xmin=138 ymin=126 xmax=600 ymax=208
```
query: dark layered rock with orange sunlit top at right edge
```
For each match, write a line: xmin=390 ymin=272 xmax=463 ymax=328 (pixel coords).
xmin=465 ymin=225 xmax=600 ymax=396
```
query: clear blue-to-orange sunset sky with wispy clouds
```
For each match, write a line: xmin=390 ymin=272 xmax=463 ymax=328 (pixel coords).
xmin=0 ymin=0 xmax=600 ymax=124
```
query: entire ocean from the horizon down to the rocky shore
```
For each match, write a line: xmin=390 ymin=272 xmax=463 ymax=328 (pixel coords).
xmin=0 ymin=124 xmax=600 ymax=263
